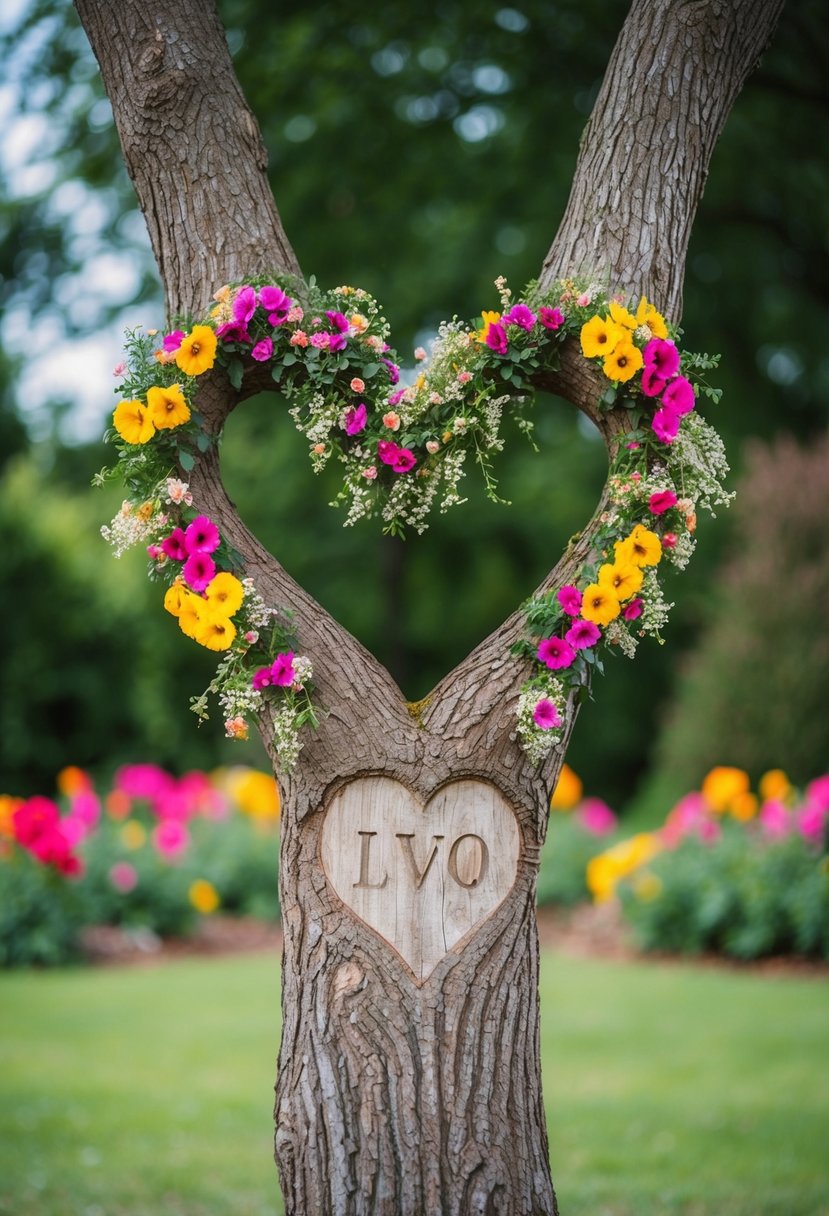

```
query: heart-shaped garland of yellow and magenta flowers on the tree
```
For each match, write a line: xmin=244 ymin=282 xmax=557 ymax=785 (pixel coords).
xmin=96 ymin=277 xmax=731 ymax=769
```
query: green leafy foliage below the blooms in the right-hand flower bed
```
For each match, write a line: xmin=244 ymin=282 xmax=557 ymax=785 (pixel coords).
xmin=619 ymin=824 xmax=829 ymax=959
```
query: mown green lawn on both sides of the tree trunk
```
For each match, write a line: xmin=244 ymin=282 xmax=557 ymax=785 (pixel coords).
xmin=0 ymin=955 xmax=829 ymax=1216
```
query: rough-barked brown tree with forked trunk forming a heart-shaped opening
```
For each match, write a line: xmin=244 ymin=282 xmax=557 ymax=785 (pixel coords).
xmin=71 ymin=0 xmax=782 ymax=1216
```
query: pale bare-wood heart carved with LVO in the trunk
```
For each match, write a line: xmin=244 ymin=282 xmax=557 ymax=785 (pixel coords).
xmin=321 ymin=777 xmax=520 ymax=983
